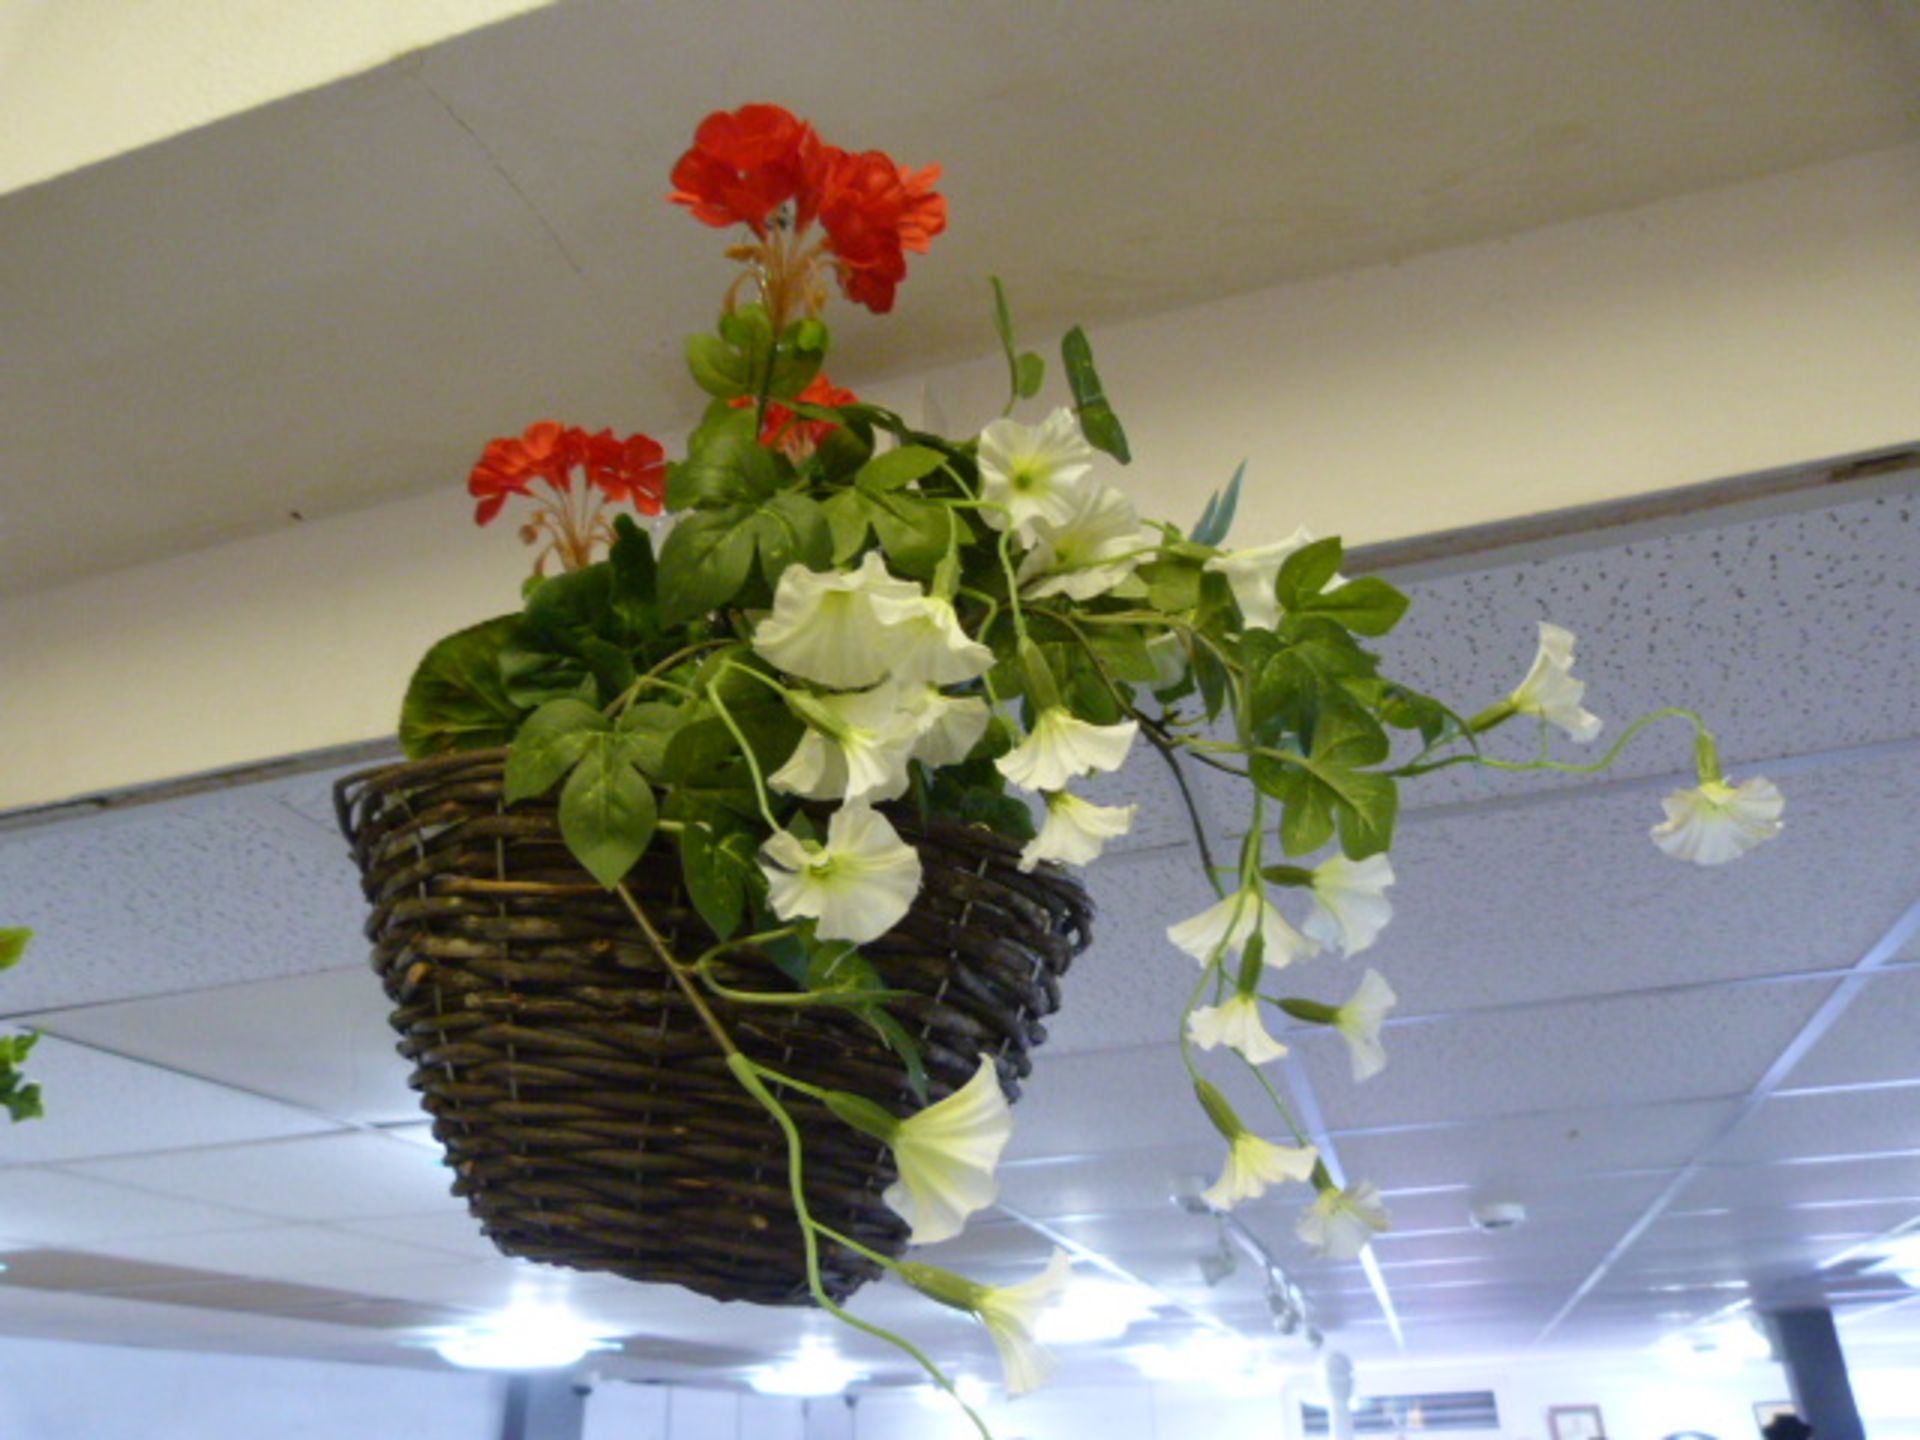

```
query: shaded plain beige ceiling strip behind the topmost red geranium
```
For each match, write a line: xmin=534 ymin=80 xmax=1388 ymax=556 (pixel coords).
xmin=0 ymin=0 xmax=1920 ymax=593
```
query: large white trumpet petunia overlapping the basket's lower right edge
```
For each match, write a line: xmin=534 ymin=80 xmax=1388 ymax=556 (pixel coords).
xmin=881 ymin=1056 xmax=1014 ymax=1244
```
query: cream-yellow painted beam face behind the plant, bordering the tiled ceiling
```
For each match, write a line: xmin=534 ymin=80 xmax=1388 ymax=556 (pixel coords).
xmin=0 ymin=146 xmax=1920 ymax=808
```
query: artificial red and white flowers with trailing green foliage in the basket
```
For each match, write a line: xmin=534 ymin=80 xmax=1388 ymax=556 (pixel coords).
xmin=349 ymin=106 xmax=1782 ymax=1434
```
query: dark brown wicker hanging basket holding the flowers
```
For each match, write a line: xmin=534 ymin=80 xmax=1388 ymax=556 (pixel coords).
xmin=334 ymin=751 xmax=1091 ymax=1304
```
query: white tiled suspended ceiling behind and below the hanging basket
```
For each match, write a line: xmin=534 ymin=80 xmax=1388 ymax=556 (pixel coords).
xmin=0 ymin=474 xmax=1920 ymax=1375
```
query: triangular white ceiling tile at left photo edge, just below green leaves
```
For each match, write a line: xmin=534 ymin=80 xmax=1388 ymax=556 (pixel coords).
xmin=0 ymin=1035 xmax=330 ymax=1169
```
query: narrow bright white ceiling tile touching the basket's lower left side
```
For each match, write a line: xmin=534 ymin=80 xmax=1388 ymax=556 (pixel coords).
xmin=71 ymin=1135 xmax=461 ymax=1221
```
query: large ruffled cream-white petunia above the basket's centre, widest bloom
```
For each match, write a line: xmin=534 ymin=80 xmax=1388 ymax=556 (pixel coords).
xmin=753 ymin=551 xmax=920 ymax=689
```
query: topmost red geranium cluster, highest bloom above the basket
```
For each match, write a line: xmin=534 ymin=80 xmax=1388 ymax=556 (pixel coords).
xmin=672 ymin=106 xmax=947 ymax=313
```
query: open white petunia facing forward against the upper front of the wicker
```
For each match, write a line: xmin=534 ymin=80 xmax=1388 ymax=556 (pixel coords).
xmin=760 ymin=804 xmax=920 ymax=945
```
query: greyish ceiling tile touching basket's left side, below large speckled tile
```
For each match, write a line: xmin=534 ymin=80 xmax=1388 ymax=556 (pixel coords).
xmin=36 ymin=966 xmax=420 ymax=1128
